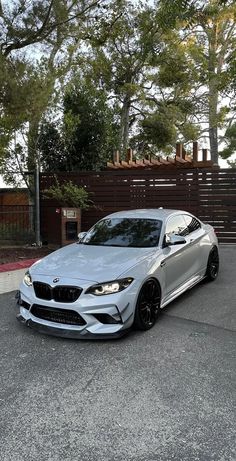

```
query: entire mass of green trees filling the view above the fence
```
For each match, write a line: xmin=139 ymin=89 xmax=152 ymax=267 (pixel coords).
xmin=0 ymin=0 xmax=236 ymax=173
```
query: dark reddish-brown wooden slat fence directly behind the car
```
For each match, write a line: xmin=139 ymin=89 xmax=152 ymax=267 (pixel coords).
xmin=40 ymin=169 xmax=236 ymax=243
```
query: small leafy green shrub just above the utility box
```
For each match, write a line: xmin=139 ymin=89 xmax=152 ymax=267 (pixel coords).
xmin=43 ymin=178 xmax=93 ymax=210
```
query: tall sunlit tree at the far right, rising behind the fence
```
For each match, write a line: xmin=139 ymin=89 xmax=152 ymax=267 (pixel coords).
xmin=158 ymin=0 xmax=236 ymax=164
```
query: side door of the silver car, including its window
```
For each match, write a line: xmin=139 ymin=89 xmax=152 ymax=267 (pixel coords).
xmin=161 ymin=214 xmax=197 ymax=296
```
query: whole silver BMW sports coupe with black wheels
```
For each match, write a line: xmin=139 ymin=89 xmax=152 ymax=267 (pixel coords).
xmin=17 ymin=208 xmax=219 ymax=338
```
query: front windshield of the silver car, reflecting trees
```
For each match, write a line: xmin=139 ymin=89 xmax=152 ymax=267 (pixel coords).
xmin=81 ymin=218 xmax=162 ymax=248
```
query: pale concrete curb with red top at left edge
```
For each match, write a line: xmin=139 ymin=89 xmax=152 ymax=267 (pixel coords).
xmin=0 ymin=258 xmax=39 ymax=294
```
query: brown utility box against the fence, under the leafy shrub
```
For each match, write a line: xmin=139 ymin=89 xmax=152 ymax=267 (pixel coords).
xmin=60 ymin=208 xmax=81 ymax=246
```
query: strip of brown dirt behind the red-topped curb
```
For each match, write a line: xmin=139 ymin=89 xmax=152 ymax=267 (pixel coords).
xmin=0 ymin=247 xmax=53 ymax=264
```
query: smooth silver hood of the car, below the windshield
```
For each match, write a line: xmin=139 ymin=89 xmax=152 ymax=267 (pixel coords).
xmin=30 ymin=243 xmax=158 ymax=283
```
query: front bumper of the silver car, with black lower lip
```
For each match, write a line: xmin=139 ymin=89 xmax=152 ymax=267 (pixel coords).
xmin=17 ymin=276 xmax=135 ymax=339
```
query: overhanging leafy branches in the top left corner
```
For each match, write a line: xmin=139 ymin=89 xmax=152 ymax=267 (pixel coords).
xmin=0 ymin=0 xmax=103 ymax=57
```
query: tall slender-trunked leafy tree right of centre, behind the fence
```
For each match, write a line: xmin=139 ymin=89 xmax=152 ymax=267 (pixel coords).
xmin=82 ymin=1 xmax=162 ymax=156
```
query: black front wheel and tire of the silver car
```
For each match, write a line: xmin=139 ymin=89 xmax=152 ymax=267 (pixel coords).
xmin=134 ymin=279 xmax=161 ymax=330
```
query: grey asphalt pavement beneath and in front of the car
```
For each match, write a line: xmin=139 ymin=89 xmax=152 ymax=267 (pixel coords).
xmin=0 ymin=247 xmax=236 ymax=461
